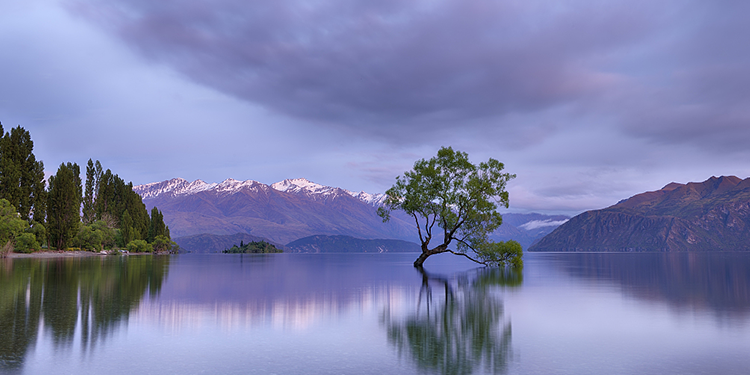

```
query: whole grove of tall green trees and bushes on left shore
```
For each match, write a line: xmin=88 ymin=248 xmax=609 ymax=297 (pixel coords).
xmin=0 ymin=124 xmax=176 ymax=256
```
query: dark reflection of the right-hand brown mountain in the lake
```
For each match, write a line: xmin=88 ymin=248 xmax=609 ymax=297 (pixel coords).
xmin=546 ymin=252 xmax=750 ymax=322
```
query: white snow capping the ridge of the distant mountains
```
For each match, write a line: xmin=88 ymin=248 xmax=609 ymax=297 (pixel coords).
xmin=133 ymin=178 xmax=385 ymax=206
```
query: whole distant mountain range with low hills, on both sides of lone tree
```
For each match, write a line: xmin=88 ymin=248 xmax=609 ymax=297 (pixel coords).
xmin=133 ymin=178 xmax=568 ymax=251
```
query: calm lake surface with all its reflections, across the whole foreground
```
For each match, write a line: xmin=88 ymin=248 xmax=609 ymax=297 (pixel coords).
xmin=0 ymin=253 xmax=750 ymax=375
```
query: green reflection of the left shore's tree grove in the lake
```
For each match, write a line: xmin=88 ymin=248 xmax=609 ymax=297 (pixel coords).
xmin=0 ymin=256 xmax=169 ymax=372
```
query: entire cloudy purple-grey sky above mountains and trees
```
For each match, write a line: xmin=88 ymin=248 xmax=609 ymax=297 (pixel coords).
xmin=0 ymin=0 xmax=750 ymax=215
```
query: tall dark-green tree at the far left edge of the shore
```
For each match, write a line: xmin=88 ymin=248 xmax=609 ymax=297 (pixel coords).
xmin=0 ymin=125 xmax=46 ymax=222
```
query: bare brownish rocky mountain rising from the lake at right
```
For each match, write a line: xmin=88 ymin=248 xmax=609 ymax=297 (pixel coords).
xmin=529 ymin=176 xmax=750 ymax=251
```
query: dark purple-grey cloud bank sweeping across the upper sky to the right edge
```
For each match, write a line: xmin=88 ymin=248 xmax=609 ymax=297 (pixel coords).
xmin=70 ymin=0 xmax=750 ymax=154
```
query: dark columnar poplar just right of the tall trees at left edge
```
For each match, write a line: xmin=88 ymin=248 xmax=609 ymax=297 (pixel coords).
xmin=47 ymin=163 xmax=82 ymax=250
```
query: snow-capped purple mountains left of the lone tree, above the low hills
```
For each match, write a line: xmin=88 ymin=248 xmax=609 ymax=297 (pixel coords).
xmin=133 ymin=179 xmax=416 ymax=243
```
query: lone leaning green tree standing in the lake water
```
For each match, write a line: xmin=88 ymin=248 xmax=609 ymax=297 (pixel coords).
xmin=378 ymin=147 xmax=523 ymax=268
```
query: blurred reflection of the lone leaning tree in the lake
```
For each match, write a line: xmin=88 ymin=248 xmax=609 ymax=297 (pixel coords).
xmin=383 ymin=268 xmax=522 ymax=374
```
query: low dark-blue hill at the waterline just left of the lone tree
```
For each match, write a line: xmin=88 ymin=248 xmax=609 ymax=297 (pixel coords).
xmin=286 ymin=236 xmax=421 ymax=253
